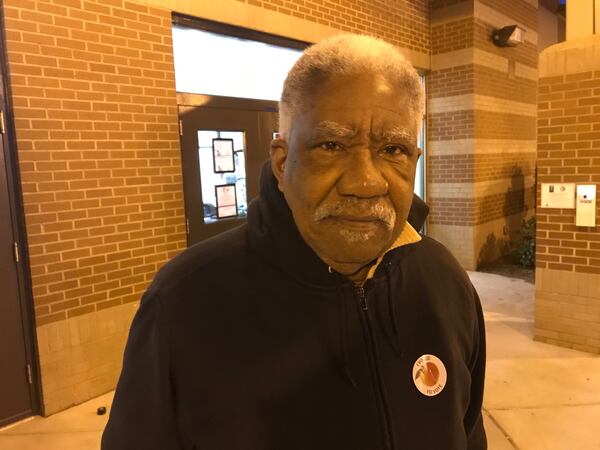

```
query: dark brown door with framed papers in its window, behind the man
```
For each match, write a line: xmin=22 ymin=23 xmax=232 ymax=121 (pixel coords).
xmin=178 ymin=94 xmax=277 ymax=245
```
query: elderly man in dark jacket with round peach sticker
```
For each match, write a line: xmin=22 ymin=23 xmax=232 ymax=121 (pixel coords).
xmin=102 ymin=35 xmax=486 ymax=450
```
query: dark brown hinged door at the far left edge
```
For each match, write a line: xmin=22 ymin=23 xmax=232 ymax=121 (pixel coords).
xmin=0 ymin=3 xmax=38 ymax=426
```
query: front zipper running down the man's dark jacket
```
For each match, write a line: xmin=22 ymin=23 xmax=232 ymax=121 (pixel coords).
xmin=356 ymin=287 xmax=395 ymax=450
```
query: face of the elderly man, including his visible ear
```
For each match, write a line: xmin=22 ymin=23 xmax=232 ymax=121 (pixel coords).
xmin=272 ymin=76 xmax=420 ymax=273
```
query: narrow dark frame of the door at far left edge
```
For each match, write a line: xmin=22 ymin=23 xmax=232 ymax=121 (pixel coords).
xmin=0 ymin=0 xmax=43 ymax=427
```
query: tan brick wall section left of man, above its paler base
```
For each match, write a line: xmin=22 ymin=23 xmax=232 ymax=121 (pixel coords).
xmin=4 ymin=0 xmax=185 ymax=326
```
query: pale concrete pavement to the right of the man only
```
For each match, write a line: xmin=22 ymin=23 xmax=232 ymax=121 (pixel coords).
xmin=476 ymin=272 xmax=600 ymax=450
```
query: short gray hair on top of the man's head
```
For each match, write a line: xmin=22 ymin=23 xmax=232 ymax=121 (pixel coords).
xmin=279 ymin=34 xmax=424 ymax=139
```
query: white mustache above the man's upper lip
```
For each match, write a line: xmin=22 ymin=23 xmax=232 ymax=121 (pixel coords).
xmin=314 ymin=198 xmax=396 ymax=228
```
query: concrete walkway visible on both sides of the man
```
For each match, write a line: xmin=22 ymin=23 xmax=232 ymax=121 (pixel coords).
xmin=0 ymin=272 xmax=600 ymax=450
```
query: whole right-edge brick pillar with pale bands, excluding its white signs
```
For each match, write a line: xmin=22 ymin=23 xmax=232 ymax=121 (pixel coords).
xmin=534 ymin=35 xmax=600 ymax=353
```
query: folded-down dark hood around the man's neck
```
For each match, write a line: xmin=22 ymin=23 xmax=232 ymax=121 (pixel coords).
xmin=248 ymin=160 xmax=429 ymax=289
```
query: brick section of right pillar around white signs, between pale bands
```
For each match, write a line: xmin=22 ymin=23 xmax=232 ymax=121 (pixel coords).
xmin=536 ymin=71 xmax=600 ymax=274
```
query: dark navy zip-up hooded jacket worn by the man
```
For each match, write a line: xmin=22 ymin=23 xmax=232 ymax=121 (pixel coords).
xmin=102 ymin=163 xmax=486 ymax=450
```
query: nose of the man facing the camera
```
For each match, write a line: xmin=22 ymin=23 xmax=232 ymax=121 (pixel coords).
xmin=337 ymin=148 xmax=388 ymax=198
